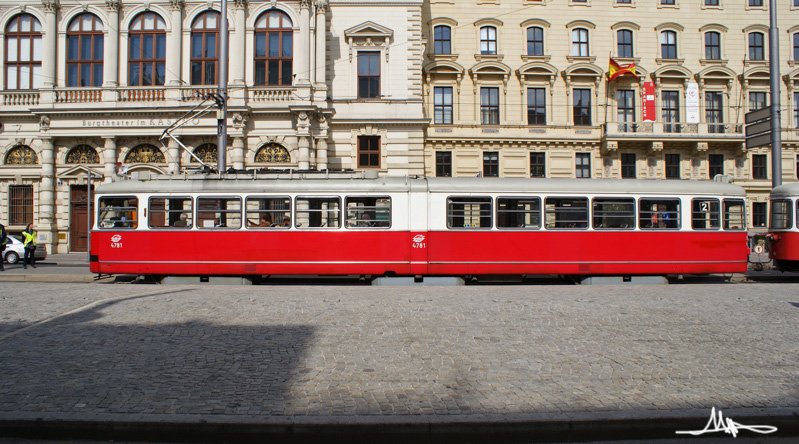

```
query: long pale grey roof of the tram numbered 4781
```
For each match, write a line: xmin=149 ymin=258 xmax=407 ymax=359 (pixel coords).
xmin=96 ymin=174 xmax=752 ymax=197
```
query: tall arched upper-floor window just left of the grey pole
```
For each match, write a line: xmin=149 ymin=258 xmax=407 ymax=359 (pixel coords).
xmin=191 ymin=11 xmax=219 ymax=85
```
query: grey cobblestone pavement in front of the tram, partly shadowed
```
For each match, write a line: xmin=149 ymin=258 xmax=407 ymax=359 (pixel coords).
xmin=0 ymin=282 xmax=799 ymax=438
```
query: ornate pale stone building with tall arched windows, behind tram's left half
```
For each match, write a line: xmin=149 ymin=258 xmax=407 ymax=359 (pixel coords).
xmin=0 ymin=0 xmax=426 ymax=253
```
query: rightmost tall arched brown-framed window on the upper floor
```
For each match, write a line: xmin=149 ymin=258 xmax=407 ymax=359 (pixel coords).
xmin=255 ymin=9 xmax=294 ymax=86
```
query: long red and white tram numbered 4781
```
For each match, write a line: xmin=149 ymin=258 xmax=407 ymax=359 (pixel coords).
xmin=91 ymin=175 xmax=748 ymax=276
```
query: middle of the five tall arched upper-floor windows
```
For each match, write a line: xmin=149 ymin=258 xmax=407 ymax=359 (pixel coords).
xmin=128 ymin=12 xmax=166 ymax=86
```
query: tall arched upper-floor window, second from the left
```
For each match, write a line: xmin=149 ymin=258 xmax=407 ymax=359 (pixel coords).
xmin=67 ymin=12 xmax=103 ymax=87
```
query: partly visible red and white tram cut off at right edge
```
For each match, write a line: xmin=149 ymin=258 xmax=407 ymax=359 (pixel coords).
xmin=769 ymin=183 xmax=799 ymax=271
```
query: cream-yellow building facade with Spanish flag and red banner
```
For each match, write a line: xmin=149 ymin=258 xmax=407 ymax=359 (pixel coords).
xmin=423 ymin=0 xmax=799 ymax=229
